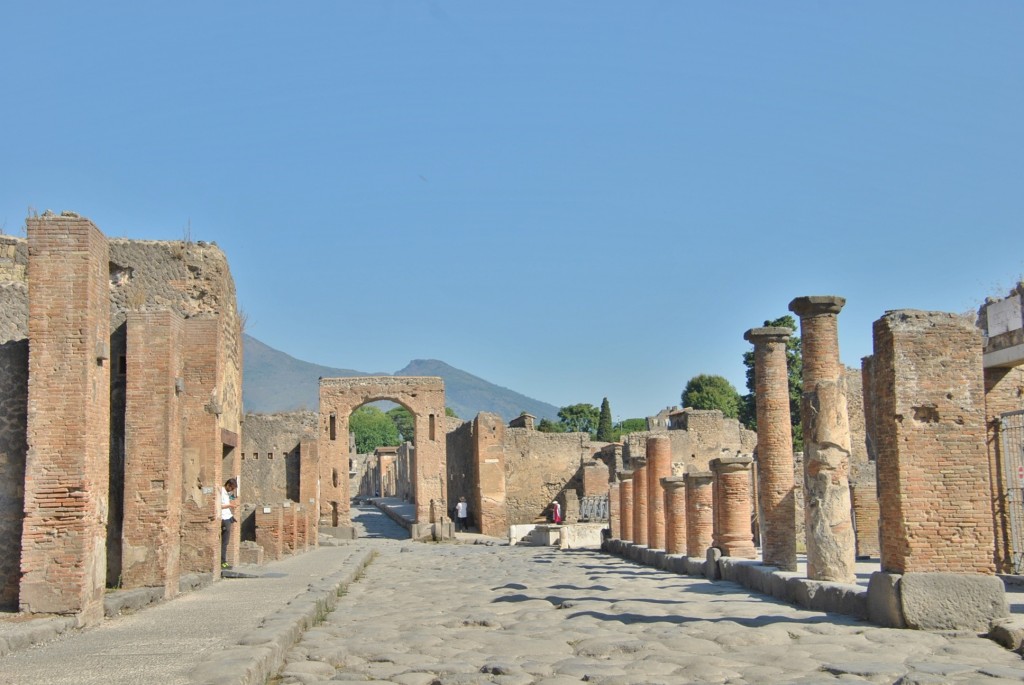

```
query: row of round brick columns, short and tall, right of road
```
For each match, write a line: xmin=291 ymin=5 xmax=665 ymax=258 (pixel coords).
xmin=612 ymin=296 xmax=855 ymax=583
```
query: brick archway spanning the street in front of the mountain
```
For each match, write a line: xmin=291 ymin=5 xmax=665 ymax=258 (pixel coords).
xmin=318 ymin=376 xmax=447 ymax=525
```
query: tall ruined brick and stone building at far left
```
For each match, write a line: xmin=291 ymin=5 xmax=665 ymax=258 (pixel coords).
xmin=0 ymin=212 xmax=242 ymax=624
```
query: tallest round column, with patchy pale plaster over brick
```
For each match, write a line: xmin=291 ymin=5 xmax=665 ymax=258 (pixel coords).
xmin=790 ymin=295 xmax=857 ymax=583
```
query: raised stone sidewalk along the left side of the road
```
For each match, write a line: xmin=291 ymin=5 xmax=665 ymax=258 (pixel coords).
xmin=0 ymin=541 xmax=373 ymax=685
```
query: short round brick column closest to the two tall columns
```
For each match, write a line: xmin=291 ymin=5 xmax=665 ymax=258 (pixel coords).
xmin=711 ymin=457 xmax=758 ymax=559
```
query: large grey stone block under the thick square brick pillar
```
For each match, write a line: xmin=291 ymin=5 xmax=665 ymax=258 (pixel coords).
xmin=899 ymin=573 xmax=1010 ymax=632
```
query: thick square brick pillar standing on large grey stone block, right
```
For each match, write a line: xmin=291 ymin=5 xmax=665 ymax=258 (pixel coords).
xmin=871 ymin=309 xmax=995 ymax=573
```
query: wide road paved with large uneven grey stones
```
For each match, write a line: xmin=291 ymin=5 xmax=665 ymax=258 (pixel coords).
xmin=281 ymin=514 xmax=1024 ymax=685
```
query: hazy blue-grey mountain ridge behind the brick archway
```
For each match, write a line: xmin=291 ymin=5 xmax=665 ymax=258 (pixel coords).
xmin=242 ymin=335 xmax=558 ymax=421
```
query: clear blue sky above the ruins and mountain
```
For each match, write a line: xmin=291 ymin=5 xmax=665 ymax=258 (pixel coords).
xmin=0 ymin=0 xmax=1024 ymax=418
